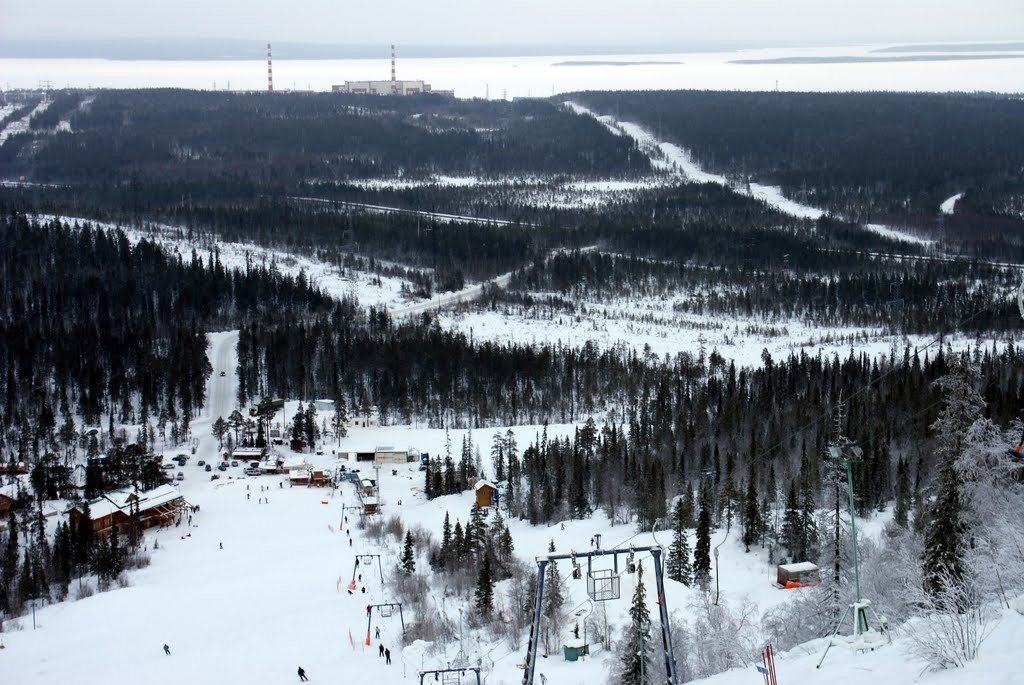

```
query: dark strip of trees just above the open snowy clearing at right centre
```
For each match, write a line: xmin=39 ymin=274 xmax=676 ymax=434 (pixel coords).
xmin=507 ymin=252 xmax=1020 ymax=334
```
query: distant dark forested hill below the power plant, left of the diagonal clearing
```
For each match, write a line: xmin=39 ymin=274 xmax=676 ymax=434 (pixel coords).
xmin=0 ymin=89 xmax=649 ymax=189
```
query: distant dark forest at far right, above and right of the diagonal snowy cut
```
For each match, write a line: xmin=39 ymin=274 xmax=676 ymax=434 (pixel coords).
xmin=573 ymin=91 xmax=1024 ymax=246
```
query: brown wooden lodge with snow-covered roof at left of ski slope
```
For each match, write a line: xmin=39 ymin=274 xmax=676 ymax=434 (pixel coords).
xmin=68 ymin=485 xmax=188 ymax=536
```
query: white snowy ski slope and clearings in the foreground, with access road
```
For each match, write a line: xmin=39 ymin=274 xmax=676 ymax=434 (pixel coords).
xmin=2 ymin=339 xmax=1024 ymax=685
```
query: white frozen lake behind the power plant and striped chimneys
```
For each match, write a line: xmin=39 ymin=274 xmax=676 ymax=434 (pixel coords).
xmin=0 ymin=45 xmax=1024 ymax=98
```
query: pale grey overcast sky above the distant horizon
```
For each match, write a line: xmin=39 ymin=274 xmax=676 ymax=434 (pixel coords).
xmin=0 ymin=0 xmax=1024 ymax=47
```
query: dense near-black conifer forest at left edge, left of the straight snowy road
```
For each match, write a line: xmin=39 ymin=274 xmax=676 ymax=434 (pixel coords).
xmin=0 ymin=215 xmax=328 ymax=438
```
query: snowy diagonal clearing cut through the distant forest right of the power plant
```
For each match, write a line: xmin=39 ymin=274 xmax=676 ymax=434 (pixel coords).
xmin=563 ymin=101 xmax=935 ymax=245
